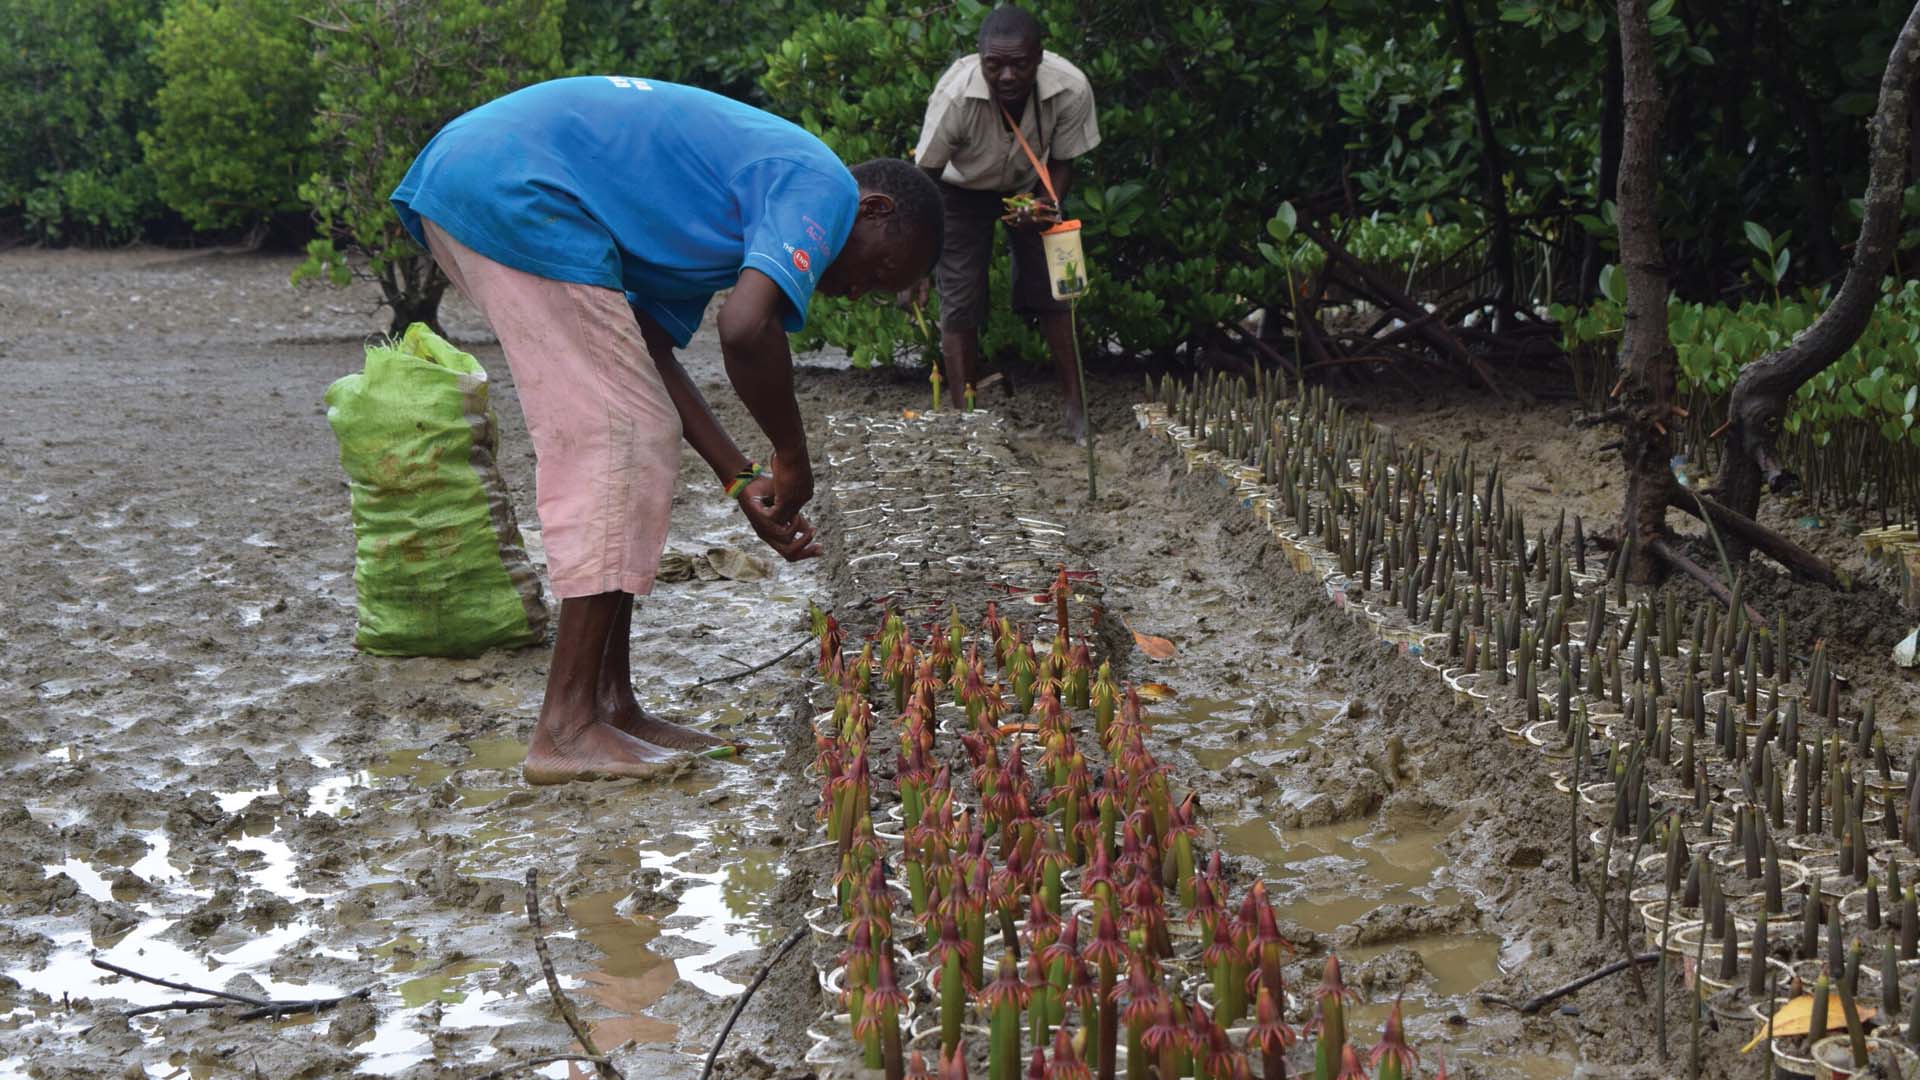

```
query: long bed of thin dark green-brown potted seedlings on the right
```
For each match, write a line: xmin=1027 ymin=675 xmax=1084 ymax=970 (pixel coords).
xmin=1137 ymin=367 xmax=1920 ymax=1076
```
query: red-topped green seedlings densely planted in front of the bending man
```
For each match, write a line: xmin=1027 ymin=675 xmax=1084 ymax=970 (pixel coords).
xmin=808 ymin=571 xmax=1446 ymax=1080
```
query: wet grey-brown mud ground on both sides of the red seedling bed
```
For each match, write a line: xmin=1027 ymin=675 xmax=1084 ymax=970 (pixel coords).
xmin=0 ymin=252 xmax=1870 ymax=1078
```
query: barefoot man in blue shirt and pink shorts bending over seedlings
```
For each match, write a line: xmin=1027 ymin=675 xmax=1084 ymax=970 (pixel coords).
xmin=392 ymin=77 xmax=943 ymax=784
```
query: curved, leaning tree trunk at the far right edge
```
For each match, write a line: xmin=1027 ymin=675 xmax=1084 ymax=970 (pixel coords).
xmin=1718 ymin=4 xmax=1920 ymax=545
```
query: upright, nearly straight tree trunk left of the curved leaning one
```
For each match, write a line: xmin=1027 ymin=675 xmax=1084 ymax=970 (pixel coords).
xmin=1619 ymin=0 xmax=1674 ymax=584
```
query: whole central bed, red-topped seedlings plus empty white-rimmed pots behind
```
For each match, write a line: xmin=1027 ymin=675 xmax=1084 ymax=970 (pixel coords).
xmin=787 ymin=413 xmax=1443 ymax=1078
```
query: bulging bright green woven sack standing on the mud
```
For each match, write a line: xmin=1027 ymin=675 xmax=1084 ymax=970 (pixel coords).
xmin=326 ymin=323 xmax=547 ymax=657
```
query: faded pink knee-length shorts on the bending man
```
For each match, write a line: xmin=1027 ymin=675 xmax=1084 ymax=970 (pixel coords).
xmin=422 ymin=221 xmax=680 ymax=600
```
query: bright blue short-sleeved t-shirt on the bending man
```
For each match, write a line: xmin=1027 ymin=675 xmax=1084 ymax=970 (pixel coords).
xmin=392 ymin=75 xmax=860 ymax=346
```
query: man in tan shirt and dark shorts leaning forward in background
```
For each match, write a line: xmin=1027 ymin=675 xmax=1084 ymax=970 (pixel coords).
xmin=914 ymin=6 xmax=1100 ymax=440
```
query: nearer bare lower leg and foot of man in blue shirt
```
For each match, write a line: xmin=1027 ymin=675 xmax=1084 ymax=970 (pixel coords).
xmin=522 ymin=592 xmax=676 ymax=784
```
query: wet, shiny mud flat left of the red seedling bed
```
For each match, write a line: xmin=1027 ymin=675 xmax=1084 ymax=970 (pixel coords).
xmin=0 ymin=252 xmax=837 ymax=1080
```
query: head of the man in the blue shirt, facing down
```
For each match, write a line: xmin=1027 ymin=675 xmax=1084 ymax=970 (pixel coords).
xmin=818 ymin=158 xmax=947 ymax=296
